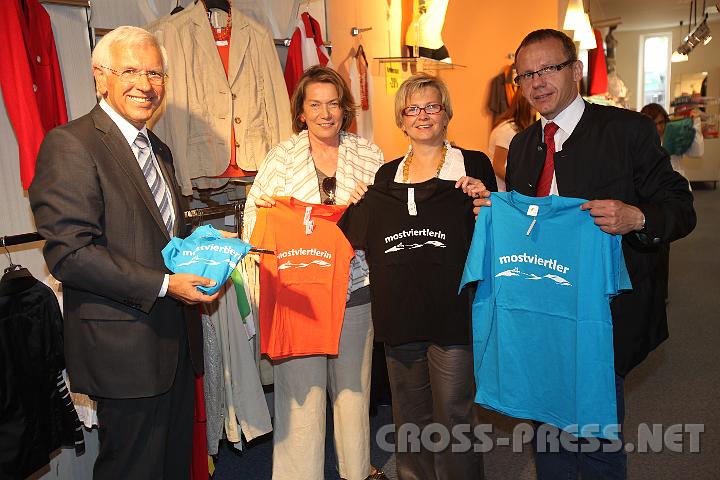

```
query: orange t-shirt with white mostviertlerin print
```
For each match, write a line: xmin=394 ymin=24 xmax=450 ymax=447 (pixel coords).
xmin=250 ymin=197 xmax=355 ymax=359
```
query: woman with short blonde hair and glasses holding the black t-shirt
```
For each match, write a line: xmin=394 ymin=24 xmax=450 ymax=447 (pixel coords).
xmin=375 ymin=73 xmax=495 ymax=480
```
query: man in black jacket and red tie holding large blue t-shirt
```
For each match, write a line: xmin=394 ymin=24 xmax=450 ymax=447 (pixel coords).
xmin=475 ymin=30 xmax=696 ymax=480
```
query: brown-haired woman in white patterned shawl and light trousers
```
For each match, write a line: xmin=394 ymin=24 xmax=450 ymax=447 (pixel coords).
xmin=243 ymin=66 xmax=385 ymax=480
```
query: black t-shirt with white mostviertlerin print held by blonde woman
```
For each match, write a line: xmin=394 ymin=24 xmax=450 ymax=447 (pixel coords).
xmin=338 ymin=179 xmax=474 ymax=346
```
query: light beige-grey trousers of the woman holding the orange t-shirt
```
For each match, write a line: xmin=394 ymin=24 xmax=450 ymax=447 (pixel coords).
xmin=272 ymin=304 xmax=373 ymax=480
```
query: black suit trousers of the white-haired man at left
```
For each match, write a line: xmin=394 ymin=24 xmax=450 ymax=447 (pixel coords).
xmin=93 ymin=343 xmax=195 ymax=480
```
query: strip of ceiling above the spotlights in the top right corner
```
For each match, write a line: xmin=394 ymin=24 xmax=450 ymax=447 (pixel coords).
xmin=584 ymin=0 xmax=720 ymax=31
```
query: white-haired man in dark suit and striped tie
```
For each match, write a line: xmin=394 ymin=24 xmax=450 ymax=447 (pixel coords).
xmin=29 ymin=27 xmax=215 ymax=480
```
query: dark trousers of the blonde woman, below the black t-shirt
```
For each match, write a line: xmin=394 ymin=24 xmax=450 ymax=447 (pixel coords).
xmin=385 ymin=342 xmax=484 ymax=480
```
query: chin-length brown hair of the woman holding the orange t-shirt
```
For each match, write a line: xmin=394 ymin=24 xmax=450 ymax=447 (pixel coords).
xmin=290 ymin=65 xmax=356 ymax=133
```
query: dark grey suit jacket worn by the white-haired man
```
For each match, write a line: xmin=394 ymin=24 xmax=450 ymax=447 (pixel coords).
xmin=29 ymin=106 xmax=202 ymax=398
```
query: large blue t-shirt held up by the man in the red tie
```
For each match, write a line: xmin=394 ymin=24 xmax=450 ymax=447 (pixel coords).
xmin=461 ymin=192 xmax=632 ymax=439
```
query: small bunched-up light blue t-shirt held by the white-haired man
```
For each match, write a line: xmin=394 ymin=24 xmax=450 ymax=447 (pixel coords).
xmin=162 ymin=225 xmax=251 ymax=295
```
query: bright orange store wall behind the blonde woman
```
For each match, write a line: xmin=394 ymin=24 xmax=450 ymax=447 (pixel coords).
xmin=328 ymin=0 xmax=566 ymax=159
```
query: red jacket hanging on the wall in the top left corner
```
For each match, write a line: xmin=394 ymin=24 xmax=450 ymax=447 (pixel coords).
xmin=0 ymin=0 xmax=67 ymax=189
